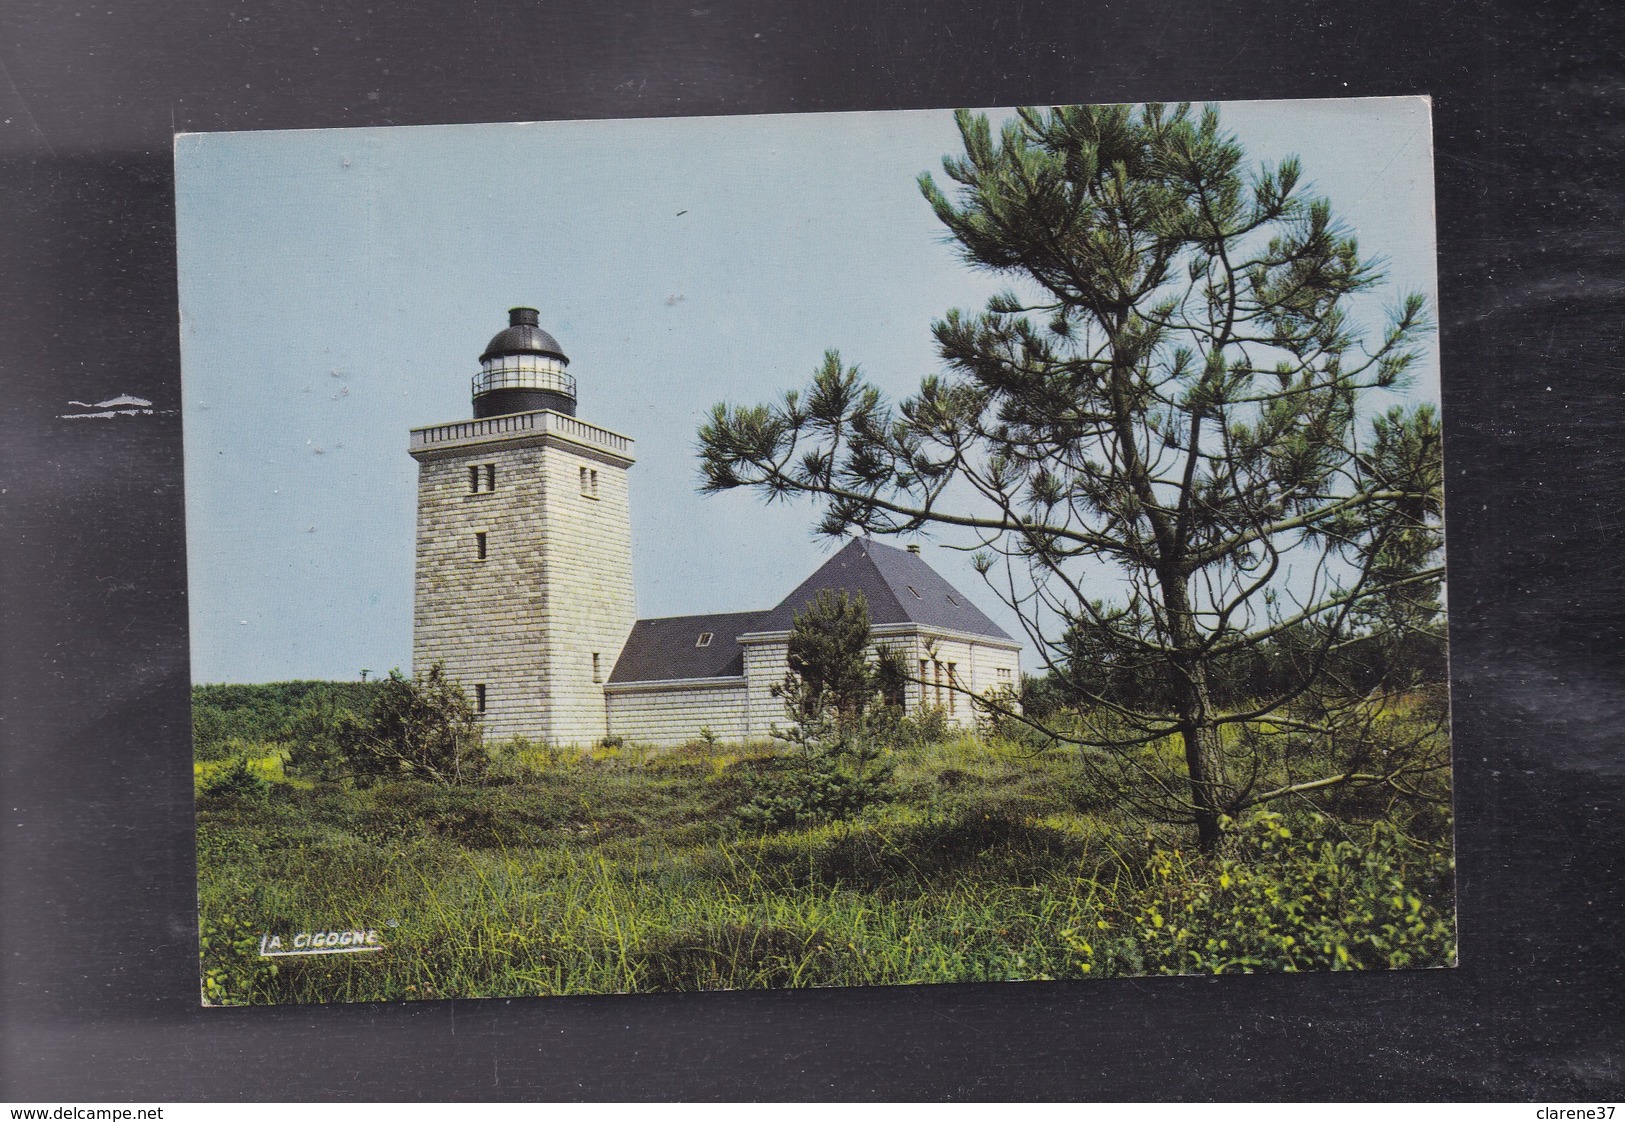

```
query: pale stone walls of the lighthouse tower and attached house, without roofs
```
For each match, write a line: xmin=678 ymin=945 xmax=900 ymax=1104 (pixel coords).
xmin=413 ymin=401 xmax=1021 ymax=746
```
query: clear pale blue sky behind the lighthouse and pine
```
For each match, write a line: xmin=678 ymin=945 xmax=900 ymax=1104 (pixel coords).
xmin=176 ymin=98 xmax=1438 ymax=681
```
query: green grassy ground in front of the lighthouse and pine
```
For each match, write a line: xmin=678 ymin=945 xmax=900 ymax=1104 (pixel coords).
xmin=198 ymin=737 xmax=1454 ymax=1003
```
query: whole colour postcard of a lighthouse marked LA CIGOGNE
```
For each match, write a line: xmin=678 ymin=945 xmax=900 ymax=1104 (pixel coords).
xmin=176 ymin=98 xmax=1456 ymax=1005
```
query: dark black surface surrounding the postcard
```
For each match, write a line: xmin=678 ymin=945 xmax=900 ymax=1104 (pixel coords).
xmin=0 ymin=0 xmax=1625 ymax=1102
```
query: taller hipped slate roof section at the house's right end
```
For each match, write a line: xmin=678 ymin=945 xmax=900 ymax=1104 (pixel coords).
xmin=752 ymin=538 xmax=1014 ymax=642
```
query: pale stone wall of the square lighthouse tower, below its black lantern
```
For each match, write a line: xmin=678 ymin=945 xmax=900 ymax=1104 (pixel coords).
xmin=413 ymin=414 xmax=635 ymax=745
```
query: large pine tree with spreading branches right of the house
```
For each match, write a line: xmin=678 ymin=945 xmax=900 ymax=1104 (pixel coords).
xmin=700 ymin=106 xmax=1443 ymax=846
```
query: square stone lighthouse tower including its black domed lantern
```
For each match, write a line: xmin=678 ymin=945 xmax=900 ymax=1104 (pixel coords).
xmin=411 ymin=307 xmax=634 ymax=745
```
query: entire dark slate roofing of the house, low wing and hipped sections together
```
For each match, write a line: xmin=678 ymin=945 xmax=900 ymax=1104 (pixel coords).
xmin=609 ymin=538 xmax=1014 ymax=685
